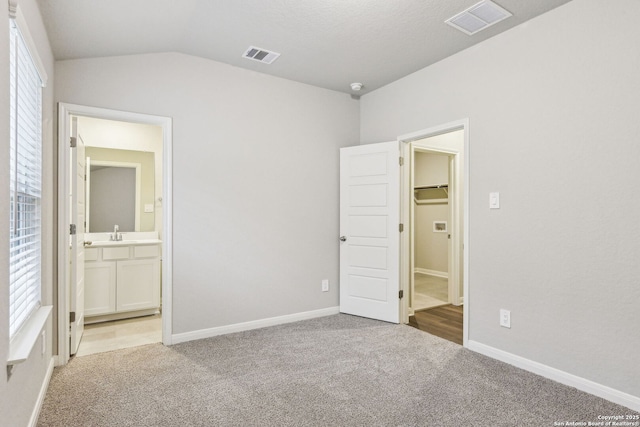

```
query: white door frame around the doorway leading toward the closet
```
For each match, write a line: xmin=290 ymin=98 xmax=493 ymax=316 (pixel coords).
xmin=397 ymin=118 xmax=469 ymax=347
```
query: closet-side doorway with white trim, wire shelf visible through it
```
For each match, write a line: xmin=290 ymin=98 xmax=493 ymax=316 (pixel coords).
xmin=399 ymin=120 xmax=468 ymax=343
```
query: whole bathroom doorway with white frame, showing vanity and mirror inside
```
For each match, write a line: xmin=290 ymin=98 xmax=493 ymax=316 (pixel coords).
xmin=58 ymin=104 xmax=171 ymax=364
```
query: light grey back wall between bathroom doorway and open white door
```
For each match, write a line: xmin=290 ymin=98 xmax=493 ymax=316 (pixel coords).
xmin=56 ymin=53 xmax=359 ymax=334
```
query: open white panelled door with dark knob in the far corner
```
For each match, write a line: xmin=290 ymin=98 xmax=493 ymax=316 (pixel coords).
xmin=340 ymin=141 xmax=400 ymax=323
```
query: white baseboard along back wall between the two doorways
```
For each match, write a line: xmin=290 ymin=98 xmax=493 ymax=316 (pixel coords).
xmin=171 ymin=307 xmax=340 ymax=344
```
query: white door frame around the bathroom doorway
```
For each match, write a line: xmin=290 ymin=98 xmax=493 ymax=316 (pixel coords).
xmin=56 ymin=102 xmax=173 ymax=366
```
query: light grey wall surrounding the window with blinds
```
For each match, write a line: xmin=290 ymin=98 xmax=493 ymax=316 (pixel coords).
xmin=0 ymin=0 xmax=55 ymax=426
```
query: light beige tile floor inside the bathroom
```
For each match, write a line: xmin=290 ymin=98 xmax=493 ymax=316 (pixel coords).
xmin=76 ymin=314 xmax=162 ymax=357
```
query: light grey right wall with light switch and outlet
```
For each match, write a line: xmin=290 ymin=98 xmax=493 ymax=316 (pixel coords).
xmin=361 ymin=0 xmax=640 ymax=402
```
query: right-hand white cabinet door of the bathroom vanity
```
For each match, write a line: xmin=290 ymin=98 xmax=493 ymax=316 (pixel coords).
xmin=116 ymin=259 xmax=160 ymax=311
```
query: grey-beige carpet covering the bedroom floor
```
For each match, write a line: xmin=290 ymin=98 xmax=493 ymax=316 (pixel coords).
xmin=38 ymin=314 xmax=633 ymax=427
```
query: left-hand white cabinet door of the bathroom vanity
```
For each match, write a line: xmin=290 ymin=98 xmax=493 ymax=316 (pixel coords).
xmin=84 ymin=261 xmax=116 ymax=316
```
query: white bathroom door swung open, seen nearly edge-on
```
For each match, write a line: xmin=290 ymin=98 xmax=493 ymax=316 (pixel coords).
xmin=69 ymin=117 xmax=85 ymax=354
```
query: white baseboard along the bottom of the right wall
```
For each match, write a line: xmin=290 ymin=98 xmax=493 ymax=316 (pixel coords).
xmin=467 ymin=340 xmax=640 ymax=412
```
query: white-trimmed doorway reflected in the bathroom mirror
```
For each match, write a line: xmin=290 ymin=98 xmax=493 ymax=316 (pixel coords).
xmin=86 ymin=158 xmax=141 ymax=233
